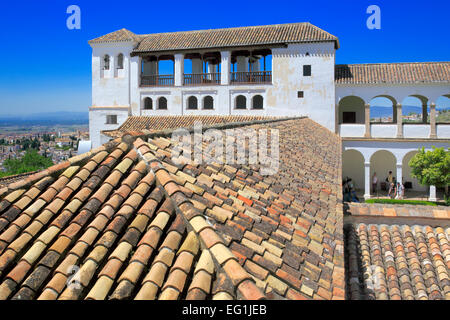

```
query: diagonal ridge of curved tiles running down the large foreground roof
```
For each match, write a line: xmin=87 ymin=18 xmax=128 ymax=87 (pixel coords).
xmin=133 ymin=138 xmax=266 ymax=300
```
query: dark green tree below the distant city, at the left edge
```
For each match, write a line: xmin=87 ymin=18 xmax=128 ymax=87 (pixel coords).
xmin=1 ymin=149 xmax=53 ymax=176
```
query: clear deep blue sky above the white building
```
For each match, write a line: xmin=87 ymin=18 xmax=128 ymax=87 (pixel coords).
xmin=0 ymin=0 xmax=450 ymax=115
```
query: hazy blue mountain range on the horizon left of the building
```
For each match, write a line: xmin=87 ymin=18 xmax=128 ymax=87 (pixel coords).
xmin=0 ymin=111 xmax=89 ymax=126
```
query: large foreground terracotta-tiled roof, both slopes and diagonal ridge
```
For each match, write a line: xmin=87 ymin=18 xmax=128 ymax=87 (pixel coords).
xmin=0 ymin=119 xmax=344 ymax=299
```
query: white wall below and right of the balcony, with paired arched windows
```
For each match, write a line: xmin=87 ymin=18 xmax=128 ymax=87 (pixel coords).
xmin=125 ymin=43 xmax=335 ymax=131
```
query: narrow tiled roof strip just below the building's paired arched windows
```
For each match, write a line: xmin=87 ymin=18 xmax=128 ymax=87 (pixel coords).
xmin=102 ymin=115 xmax=281 ymax=138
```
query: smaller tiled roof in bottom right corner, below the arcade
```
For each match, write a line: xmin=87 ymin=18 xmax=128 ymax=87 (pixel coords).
xmin=344 ymin=203 xmax=450 ymax=300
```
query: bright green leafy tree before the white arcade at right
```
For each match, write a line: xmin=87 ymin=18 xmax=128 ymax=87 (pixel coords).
xmin=409 ymin=146 xmax=450 ymax=194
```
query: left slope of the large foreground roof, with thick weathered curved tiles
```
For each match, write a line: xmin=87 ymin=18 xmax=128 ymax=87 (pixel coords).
xmin=0 ymin=142 xmax=236 ymax=300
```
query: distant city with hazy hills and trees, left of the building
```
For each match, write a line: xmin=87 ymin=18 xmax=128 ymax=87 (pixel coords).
xmin=0 ymin=112 xmax=89 ymax=178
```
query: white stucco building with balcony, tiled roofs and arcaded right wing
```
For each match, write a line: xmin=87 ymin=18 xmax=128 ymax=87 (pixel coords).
xmin=89 ymin=23 xmax=450 ymax=198
